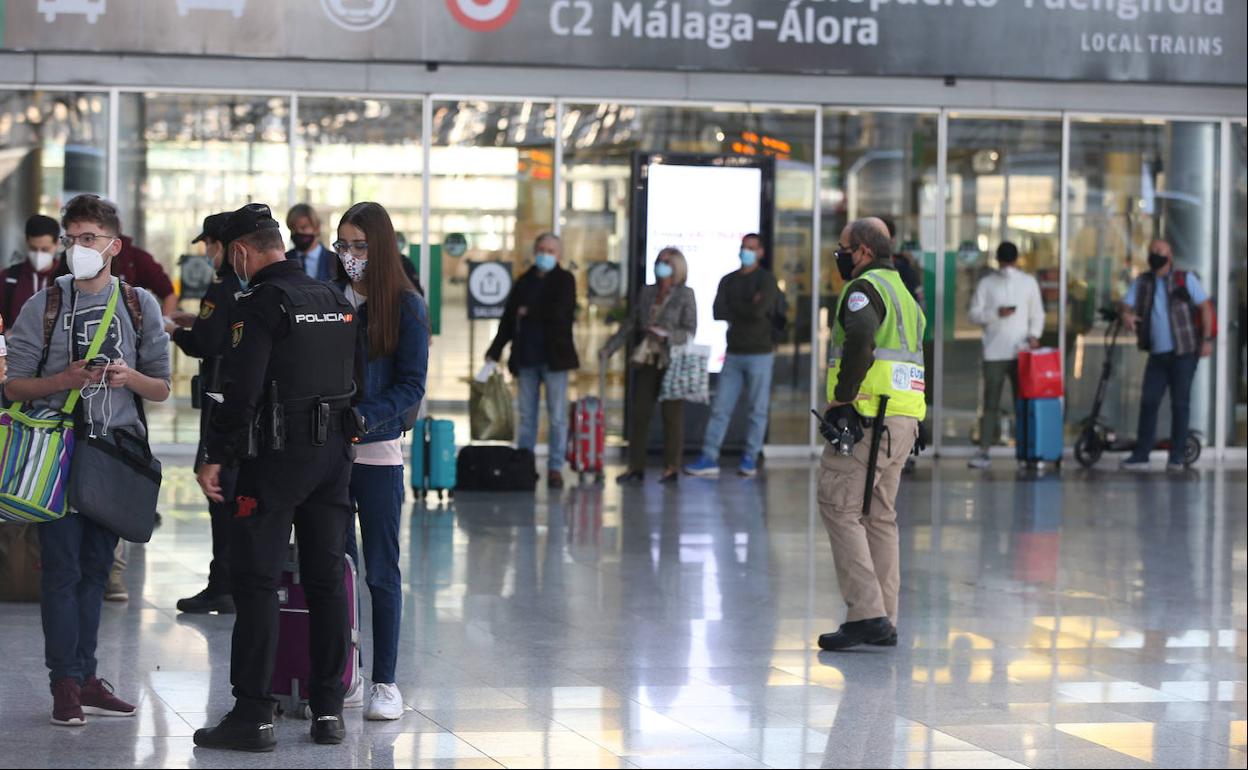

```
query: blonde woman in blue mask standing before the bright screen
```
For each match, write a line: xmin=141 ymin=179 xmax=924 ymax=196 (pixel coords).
xmin=599 ymin=246 xmax=698 ymax=483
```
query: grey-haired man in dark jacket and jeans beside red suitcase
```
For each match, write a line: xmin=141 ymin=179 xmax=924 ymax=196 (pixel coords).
xmin=485 ymin=232 xmax=580 ymax=489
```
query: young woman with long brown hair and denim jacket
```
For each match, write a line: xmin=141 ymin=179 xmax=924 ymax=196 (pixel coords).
xmin=333 ymin=202 xmax=429 ymax=720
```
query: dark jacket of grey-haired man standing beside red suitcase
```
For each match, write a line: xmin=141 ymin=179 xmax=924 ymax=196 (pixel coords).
xmin=487 ymin=266 xmax=580 ymax=373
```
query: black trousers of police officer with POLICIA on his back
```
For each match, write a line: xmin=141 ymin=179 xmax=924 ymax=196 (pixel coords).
xmin=230 ymin=434 xmax=351 ymax=721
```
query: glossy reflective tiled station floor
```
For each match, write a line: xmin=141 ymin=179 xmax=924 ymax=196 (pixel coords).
xmin=0 ymin=463 xmax=1248 ymax=768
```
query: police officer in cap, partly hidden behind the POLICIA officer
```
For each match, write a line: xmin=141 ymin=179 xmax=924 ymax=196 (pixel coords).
xmin=170 ymin=211 xmax=242 ymax=614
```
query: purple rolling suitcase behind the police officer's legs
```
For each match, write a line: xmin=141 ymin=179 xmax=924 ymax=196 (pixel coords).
xmin=270 ymin=544 xmax=362 ymax=719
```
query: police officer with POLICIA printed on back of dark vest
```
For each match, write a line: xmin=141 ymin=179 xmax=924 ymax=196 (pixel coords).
xmin=195 ymin=203 xmax=363 ymax=751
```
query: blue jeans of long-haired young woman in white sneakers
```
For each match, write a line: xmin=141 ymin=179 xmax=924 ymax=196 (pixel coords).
xmin=347 ymin=463 xmax=403 ymax=684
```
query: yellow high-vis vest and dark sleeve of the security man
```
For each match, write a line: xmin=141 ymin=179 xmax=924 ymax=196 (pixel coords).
xmin=827 ymin=270 xmax=927 ymax=421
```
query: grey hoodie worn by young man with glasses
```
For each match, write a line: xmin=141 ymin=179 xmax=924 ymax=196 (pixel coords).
xmin=7 ymin=276 xmax=171 ymax=433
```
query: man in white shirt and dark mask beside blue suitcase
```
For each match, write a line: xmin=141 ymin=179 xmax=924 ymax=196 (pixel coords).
xmin=967 ymin=241 xmax=1045 ymax=468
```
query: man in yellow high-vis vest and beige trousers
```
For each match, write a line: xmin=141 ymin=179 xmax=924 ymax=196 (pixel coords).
xmin=819 ymin=218 xmax=926 ymax=650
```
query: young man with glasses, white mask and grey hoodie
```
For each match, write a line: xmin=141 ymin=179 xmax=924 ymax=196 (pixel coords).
xmin=5 ymin=195 xmax=170 ymax=726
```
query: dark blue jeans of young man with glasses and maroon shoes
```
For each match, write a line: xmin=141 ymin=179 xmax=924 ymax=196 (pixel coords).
xmin=39 ymin=513 xmax=117 ymax=684
